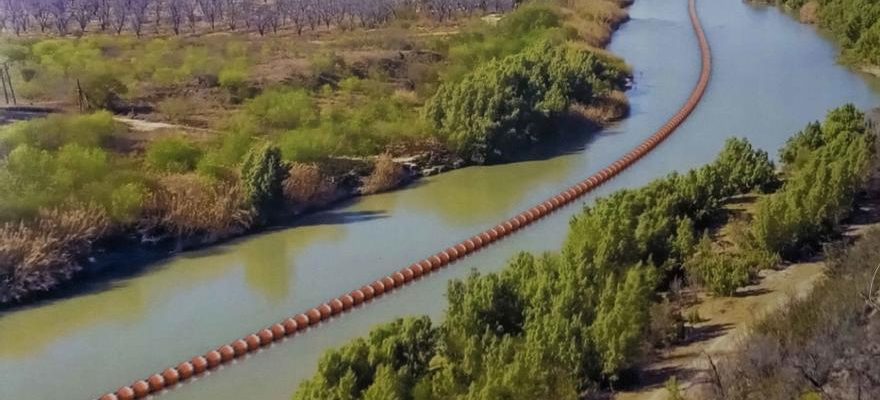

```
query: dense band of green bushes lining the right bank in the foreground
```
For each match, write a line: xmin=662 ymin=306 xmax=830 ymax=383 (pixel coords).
xmin=294 ymin=106 xmax=875 ymax=399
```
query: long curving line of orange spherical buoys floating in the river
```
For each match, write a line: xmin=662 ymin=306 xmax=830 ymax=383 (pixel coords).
xmin=100 ymin=0 xmax=712 ymax=400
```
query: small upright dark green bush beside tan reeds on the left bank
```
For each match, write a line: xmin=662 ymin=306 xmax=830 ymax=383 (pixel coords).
xmin=241 ymin=143 xmax=287 ymax=217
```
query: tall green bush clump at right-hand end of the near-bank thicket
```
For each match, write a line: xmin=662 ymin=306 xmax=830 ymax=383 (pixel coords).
xmin=751 ymin=105 xmax=874 ymax=258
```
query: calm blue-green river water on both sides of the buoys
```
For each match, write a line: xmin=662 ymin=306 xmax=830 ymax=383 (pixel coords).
xmin=0 ymin=0 xmax=880 ymax=400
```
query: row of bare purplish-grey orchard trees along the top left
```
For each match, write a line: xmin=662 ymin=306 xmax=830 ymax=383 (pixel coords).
xmin=0 ymin=0 xmax=519 ymax=36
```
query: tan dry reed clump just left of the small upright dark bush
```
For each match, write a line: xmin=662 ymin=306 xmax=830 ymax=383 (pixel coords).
xmin=142 ymin=174 xmax=254 ymax=242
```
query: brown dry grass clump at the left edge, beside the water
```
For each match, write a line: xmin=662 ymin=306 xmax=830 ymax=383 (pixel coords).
xmin=0 ymin=206 xmax=112 ymax=303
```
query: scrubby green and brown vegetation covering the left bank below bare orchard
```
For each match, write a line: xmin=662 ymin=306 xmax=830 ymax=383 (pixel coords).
xmin=0 ymin=0 xmax=629 ymax=303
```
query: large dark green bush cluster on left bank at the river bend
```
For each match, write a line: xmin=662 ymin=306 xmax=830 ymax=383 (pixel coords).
xmin=424 ymin=41 xmax=623 ymax=162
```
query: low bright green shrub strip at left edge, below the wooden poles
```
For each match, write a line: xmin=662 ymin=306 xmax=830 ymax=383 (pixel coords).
xmin=0 ymin=111 xmax=119 ymax=153
